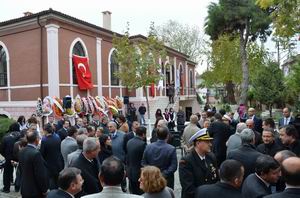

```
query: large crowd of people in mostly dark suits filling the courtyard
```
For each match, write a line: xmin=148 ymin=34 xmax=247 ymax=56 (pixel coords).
xmin=0 ymin=105 xmax=300 ymax=198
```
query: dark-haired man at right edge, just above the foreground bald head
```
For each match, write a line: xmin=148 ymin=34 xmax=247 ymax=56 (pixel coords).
xmin=279 ymin=125 xmax=300 ymax=157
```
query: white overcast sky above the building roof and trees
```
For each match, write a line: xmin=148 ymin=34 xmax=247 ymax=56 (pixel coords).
xmin=0 ymin=0 xmax=298 ymax=71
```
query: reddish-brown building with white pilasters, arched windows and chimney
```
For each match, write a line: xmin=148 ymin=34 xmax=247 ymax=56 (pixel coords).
xmin=0 ymin=9 xmax=198 ymax=121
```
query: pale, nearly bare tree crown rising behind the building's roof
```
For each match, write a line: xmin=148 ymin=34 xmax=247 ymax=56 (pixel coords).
xmin=156 ymin=20 xmax=207 ymax=62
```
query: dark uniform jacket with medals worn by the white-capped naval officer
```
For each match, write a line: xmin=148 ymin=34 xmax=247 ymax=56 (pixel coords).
xmin=179 ymin=149 xmax=218 ymax=198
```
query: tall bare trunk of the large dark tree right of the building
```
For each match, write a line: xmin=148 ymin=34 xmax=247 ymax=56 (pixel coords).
xmin=240 ymin=31 xmax=249 ymax=105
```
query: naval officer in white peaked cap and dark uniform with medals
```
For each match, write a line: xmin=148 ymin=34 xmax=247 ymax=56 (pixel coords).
xmin=179 ymin=128 xmax=218 ymax=198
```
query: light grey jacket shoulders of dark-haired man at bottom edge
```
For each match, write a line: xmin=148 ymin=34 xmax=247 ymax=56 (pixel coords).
xmin=82 ymin=186 xmax=142 ymax=198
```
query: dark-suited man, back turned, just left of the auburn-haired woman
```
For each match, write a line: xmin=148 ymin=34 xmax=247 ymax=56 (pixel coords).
xmin=126 ymin=126 xmax=147 ymax=195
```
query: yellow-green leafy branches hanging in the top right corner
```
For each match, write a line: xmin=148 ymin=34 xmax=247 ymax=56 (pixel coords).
xmin=256 ymin=0 xmax=300 ymax=38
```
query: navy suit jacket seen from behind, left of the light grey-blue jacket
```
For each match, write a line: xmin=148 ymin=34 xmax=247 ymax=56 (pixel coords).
xmin=40 ymin=134 xmax=64 ymax=177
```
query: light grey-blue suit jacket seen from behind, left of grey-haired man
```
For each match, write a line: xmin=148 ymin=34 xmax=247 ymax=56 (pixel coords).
xmin=60 ymin=136 xmax=78 ymax=168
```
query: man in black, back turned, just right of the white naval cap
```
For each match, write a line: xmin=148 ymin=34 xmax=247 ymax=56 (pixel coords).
xmin=207 ymin=113 xmax=232 ymax=165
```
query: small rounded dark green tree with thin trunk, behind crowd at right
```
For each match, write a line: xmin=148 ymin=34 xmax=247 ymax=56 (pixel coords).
xmin=252 ymin=62 xmax=285 ymax=117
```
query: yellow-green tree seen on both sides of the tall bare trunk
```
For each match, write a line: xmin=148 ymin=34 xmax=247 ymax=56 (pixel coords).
xmin=201 ymin=35 xmax=266 ymax=104
